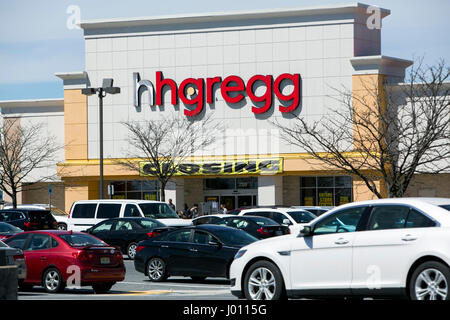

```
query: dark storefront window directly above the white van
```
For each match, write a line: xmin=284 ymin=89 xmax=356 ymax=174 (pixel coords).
xmin=109 ymin=180 xmax=159 ymax=200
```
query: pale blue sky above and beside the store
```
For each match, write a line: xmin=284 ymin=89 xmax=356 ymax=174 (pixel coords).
xmin=0 ymin=0 xmax=450 ymax=100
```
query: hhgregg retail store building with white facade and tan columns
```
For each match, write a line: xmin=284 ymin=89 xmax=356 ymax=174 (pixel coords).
xmin=0 ymin=3 xmax=450 ymax=211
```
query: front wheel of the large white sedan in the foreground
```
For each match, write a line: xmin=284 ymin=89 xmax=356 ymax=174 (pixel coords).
xmin=244 ymin=261 xmax=285 ymax=300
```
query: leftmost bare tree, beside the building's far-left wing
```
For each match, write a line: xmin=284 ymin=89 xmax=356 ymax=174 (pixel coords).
xmin=0 ymin=118 xmax=62 ymax=208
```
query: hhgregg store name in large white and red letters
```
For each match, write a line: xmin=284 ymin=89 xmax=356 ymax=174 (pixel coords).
xmin=133 ymin=71 xmax=301 ymax=117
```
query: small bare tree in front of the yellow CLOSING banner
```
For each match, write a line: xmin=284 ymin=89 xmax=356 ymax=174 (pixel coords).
xmin=119 ymin=115 xmax=221 ymax=201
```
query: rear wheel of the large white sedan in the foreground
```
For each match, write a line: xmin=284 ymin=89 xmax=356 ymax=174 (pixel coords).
xmin=409 ymin=261 xmax=450 ymax=300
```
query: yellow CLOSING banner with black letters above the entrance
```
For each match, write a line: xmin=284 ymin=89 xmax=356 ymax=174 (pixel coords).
xmin=139 ymin=158 xmax=283 ymax=176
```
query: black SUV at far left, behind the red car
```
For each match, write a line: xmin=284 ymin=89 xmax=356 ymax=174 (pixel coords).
xmin=0 ymin=208 xmax=58 ymax=231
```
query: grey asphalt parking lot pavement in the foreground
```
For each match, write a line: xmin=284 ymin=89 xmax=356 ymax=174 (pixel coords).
xmin=18 ymin=259 xmax=236 ymax=300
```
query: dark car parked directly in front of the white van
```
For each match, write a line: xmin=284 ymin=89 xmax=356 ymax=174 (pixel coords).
xmin=85 ymin=218 xmax=171 ymax=259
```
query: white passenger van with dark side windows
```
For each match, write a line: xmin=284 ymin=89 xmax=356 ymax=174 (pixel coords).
xmin=67 ymin=200 xmax=192 ymax=231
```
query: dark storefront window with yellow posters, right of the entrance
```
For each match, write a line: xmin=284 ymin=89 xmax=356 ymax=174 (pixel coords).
xmin=300 ymin=176 xmax=353 ymax=207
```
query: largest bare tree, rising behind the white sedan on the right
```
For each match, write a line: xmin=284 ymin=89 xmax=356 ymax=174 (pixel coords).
xmin=275 ymin=60 xmax=450 ymax=198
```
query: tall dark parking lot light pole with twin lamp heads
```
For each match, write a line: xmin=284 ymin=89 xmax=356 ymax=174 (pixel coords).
xmin=81 ymin=78 xmax=120 ymax=199
